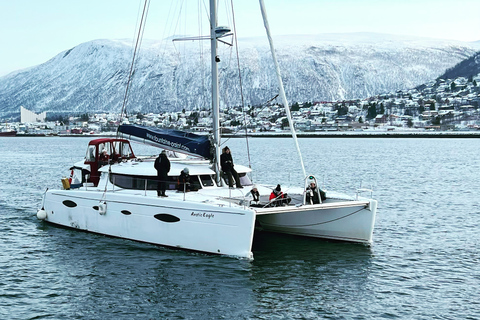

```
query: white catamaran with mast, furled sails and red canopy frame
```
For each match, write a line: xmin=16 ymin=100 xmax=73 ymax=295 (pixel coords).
xmin=37 ymin=0 xmax=377 ymax=259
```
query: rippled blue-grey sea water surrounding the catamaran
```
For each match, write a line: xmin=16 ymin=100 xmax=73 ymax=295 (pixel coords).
xmin=0 ymin=137 xmax=480 ymax=319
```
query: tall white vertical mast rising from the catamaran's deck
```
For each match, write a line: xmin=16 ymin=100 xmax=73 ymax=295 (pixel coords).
xmin=210 ymin=0 xmax=221 ymax=184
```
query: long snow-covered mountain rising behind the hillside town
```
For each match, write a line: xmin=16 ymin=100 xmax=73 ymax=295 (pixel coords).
xmin=0 ymin=33 xmax=480 ymax=117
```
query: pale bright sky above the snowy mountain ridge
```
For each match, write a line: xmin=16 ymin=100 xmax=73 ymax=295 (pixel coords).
xmin=0 ymin=0 xmax=480 ymax=76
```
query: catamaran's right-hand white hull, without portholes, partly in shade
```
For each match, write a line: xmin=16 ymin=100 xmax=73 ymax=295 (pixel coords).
xmin=257 ymin=200 xmax=377 ymax=244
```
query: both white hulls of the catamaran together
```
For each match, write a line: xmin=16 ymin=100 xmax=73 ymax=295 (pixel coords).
xmin=44 ymin=190 xmax=377 ymax=259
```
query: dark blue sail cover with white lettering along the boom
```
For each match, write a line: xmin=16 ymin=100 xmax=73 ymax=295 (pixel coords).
xmin=118 ymin=124 xmax=212 ymax=159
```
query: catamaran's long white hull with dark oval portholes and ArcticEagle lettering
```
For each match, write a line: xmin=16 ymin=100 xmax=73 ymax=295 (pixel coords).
xmin=43 ymin=190 xmax=255 ymax=259
